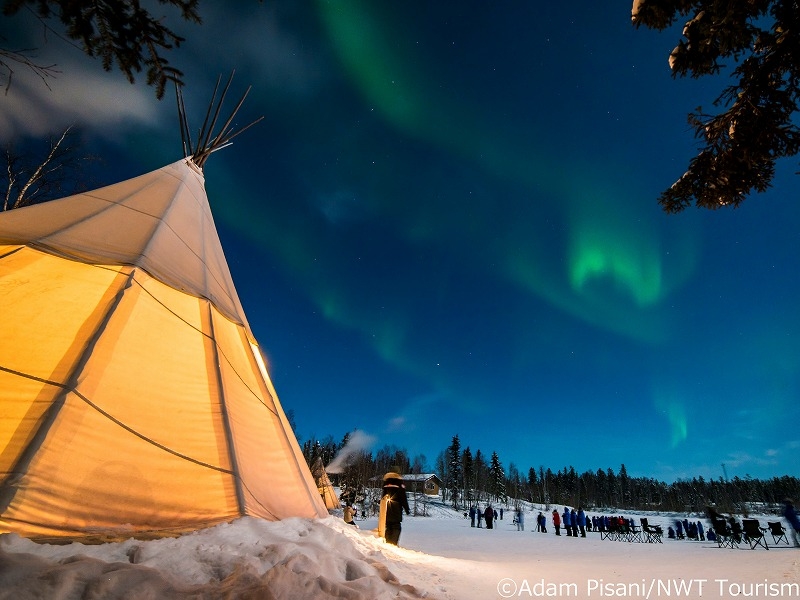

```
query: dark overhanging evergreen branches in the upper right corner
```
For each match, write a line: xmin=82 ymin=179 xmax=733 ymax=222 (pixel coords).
xmin=632 ymin=0 xmax=800 ymax=213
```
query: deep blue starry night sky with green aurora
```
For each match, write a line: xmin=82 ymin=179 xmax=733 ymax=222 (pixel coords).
xmin=0 ymin=0 xmax=800 ymax=481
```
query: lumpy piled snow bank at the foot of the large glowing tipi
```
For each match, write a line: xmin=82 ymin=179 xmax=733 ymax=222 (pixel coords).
xmin=0 ymin=517 xmax=424 ymax=600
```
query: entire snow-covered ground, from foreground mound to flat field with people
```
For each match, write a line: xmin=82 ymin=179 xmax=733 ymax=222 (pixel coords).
xmin=0 ymin=506 xmax=800 ymax=600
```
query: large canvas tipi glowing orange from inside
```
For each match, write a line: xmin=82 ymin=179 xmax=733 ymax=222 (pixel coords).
xmin=0 ymin=158 xmax=327 ymax=539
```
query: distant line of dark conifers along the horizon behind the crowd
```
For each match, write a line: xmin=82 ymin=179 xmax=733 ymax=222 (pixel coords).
xmin=302 ymin=433 xmax=800 ymax=514
